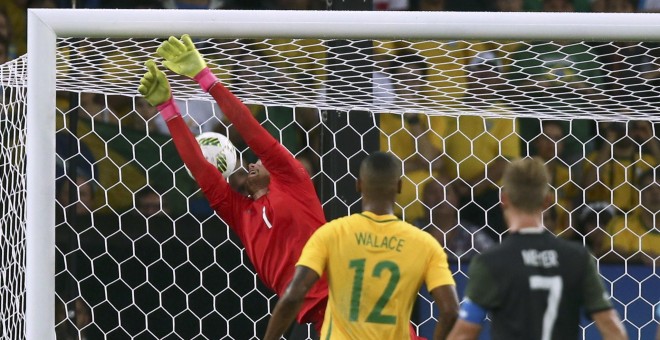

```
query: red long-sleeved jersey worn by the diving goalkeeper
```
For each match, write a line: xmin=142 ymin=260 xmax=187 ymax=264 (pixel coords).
xmin=167 ymin=83 xmax=328 ymax=327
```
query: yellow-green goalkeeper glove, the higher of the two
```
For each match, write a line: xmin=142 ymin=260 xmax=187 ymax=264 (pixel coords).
xmin=156 ymin=34 xmax=206 ymax=78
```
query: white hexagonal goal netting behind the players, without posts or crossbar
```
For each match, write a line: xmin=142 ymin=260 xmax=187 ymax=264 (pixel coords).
xmin=2 ymin=12 xmax=660 ymax=339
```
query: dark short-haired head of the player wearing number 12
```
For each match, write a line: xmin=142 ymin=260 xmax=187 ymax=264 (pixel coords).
xmin=360 ymin=151 xmax=401 ymax=199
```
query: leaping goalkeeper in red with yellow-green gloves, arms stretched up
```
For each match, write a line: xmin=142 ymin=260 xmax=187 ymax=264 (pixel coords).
xmin=138 ymin=35 xmax=328 ymax=338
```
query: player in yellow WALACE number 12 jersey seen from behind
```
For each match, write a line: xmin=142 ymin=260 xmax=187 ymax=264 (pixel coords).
xmin=265 ymin=152 xmax=458 ymax=340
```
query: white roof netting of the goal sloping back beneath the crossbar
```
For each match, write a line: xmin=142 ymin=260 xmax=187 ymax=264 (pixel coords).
xmin=58 ymin=38 xmax=658 ymax=120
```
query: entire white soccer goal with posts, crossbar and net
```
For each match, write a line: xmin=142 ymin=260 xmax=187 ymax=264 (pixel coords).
xmin=0 ymin=10 xmax=660 ymax=339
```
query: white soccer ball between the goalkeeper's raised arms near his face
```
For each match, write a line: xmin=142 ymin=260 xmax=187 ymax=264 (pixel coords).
xmin=186 ymin=132 xmax=237 ymax=178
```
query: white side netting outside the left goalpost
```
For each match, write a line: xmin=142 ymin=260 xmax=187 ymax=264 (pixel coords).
xmin=0 ymin=58 xmax=26 ymax=339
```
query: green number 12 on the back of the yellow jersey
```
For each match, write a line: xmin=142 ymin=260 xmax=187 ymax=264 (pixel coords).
xmin=348 ymin=259 xmax=401 ymax=324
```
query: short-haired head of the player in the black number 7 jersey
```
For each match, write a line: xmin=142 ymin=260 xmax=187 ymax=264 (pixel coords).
xmin=502 ymin=157 xmax=550 ymax=213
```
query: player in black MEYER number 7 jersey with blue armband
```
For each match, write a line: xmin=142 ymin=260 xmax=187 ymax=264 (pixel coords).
xmin=448 ymin=158 xmax=627 ymax=340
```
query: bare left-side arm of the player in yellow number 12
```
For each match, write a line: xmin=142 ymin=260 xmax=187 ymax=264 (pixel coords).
xmin=264 ymin=266 xmax=320 ymax=340
